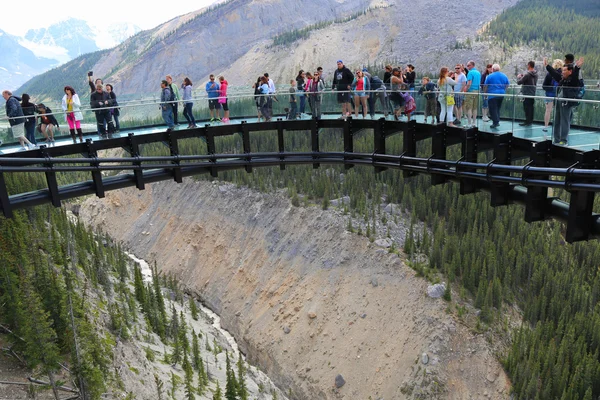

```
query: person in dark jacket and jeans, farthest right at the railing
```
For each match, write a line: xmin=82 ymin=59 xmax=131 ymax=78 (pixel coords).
xmin=544 ymin=57 xmax=583 ymax=146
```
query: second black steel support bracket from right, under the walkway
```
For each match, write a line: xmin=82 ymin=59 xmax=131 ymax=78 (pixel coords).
xmin=521 ymin=140 xmax=552 ymax=222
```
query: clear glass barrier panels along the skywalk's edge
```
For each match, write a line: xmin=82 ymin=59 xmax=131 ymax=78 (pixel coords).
xmin=0 ymin=83 xmax=600 ymax=154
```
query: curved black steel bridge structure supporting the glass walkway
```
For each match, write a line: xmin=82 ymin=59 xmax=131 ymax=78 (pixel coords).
xmin=0 ymin=118 xmax=600 ymax=242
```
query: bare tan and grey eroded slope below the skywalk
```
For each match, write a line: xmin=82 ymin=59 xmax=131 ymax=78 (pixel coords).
xmin=80 ymin=180 xmax=509 ymax=399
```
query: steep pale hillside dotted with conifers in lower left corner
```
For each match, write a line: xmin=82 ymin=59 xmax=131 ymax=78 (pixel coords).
xmin=0 ymin=174 xmax=284 ymax=400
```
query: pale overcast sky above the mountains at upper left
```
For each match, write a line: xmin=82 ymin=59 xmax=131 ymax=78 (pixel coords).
xmin=0 ymin=0 xmax=216 ymax=36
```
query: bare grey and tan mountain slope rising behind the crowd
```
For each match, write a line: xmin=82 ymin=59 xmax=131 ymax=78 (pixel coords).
xmin=16 ymin=0 xmax=516 ymax=95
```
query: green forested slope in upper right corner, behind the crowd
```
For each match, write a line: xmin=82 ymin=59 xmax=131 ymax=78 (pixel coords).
xmin=483 ymin=0 xmax=600 ymax=73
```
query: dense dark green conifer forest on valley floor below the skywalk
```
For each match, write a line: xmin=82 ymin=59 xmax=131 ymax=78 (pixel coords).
xmin=122 ymin=130 xmax=600 ymax=399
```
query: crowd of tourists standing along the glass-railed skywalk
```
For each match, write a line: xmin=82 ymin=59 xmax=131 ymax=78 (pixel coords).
xmin=2 ymin=54 xmax=585 ymax=149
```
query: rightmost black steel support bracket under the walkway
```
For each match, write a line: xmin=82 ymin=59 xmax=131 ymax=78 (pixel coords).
xmin=565 ymin=150 xmax=600 ymax=243
